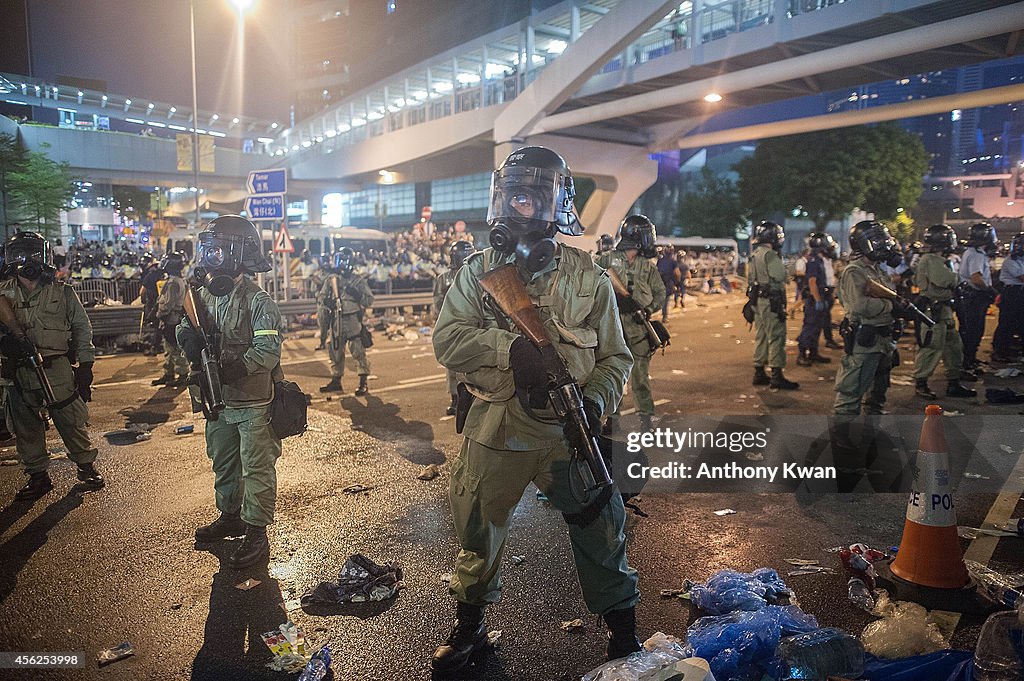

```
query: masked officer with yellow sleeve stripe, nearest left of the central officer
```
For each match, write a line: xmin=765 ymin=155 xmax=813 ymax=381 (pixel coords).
xmin=177 ymin=215 xmax=284 ymax=568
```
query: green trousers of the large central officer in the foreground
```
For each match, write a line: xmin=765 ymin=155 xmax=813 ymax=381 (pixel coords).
xmin=449 ymin=439 xmax=640 ymax=614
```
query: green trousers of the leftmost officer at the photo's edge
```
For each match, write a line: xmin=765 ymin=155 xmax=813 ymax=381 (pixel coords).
xmin=4 ymin=357 xmax=96 ymax=474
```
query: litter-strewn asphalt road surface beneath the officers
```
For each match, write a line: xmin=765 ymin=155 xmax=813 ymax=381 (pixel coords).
xmin=0 ymin=288 xmax=1024 ymax=681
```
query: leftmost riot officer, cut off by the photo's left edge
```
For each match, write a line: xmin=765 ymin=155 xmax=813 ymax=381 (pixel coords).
xmin=0 ymin=231 xmax=104 ymax=501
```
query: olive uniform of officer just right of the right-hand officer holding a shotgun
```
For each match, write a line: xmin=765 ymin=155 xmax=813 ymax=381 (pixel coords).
xmin=913 ymin=253 xmax=964 ymax=381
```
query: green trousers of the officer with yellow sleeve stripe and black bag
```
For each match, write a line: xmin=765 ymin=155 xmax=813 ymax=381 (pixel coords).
xmin=206 ymin=407 xmax=281 ymax=527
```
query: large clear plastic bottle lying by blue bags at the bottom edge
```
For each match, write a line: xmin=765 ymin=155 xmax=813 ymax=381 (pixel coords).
xmin=779 ymin=629 xmax=864 ymax=681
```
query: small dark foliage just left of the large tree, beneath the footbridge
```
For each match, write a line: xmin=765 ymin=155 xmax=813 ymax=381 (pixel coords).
xmin=677 ymin=167 xmax=746 ymax=239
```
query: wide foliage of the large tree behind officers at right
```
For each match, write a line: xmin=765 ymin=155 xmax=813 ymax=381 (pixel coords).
xmin=735 ymin=124 xmax=928 ymax=229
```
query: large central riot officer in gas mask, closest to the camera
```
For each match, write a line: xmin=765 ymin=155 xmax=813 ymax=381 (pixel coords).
xmin=433 ymin=146 xmax=639 ymax=673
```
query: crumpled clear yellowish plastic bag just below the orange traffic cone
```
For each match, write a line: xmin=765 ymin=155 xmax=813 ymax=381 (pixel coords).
xmin=860 ymin=589 xmax=949 ymax=659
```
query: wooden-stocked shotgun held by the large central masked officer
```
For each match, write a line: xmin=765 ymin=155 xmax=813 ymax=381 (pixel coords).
xmin=479 ymin=263 xmax=612 ymax=492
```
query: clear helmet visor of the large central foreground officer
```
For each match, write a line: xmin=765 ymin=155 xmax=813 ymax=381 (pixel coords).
xmin=487 ymin=166 xmax=561 ymax=223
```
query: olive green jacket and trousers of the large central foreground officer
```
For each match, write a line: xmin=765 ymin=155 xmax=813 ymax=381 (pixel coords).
xmin=433 ymin=245 xmax=639 ymax=613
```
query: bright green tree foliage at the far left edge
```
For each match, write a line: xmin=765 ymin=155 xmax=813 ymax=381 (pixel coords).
xmin=10 ymin=142 xmax=75 ymax=237
